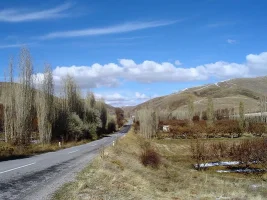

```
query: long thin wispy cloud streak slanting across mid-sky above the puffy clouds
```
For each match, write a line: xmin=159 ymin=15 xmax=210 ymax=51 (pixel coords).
xmin=40 ymin=20 xmax=181 ymax=39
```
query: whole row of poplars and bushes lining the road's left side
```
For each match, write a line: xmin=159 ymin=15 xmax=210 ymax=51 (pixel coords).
xmin=1 ymin=48 xmax=115 ymax=145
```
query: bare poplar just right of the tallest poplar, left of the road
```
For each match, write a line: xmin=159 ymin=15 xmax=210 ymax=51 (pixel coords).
xmin=35 ymin=65 xmax=55 ymax=144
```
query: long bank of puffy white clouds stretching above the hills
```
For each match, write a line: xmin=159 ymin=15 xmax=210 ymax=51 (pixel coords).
xmin=35 ymin=52 xmax=267 ymax=92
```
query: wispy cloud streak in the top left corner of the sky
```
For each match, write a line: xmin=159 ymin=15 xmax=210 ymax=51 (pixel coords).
xmin=0 ymin=3 xmax=72 ymax=22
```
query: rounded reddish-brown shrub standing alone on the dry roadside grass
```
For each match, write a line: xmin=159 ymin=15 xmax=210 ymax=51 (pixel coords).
xmin=140 ymin=147 xmax=161 ymax=169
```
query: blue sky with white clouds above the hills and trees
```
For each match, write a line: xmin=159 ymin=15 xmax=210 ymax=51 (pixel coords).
xmin=0 ymin=0 xmax=267 ymax=106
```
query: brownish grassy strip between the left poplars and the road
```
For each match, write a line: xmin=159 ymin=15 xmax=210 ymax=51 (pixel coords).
xmin=0 ymin=140 xmax=90 ymax=161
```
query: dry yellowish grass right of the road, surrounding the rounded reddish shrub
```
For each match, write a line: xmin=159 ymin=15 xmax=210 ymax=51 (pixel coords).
xmin=54 ymin=129 xmax=267 ymax=200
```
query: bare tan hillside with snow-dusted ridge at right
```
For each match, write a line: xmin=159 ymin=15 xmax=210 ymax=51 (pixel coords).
xmin=126 ymin=76 xmax=267 ymax=113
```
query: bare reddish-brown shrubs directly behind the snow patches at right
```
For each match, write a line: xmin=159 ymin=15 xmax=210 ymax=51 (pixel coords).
xmin=191 ymin=138 xmax=267 ymax=169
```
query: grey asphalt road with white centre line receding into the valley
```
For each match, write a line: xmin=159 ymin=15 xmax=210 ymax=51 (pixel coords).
xmin=0 ymin=125 xmax=130 ymax=200
